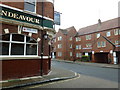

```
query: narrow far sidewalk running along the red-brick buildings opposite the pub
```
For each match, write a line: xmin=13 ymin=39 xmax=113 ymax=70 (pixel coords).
xmin=52 ymin=59 xmax=120 ymax=69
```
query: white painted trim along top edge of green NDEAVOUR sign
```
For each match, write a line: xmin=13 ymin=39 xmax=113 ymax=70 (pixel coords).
xmin=0 ymin=4 xmax=54 ymax=21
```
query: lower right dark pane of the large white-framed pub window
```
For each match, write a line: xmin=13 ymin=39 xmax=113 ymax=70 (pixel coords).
xmin=26 ymin=44 xmax=37 ymax=55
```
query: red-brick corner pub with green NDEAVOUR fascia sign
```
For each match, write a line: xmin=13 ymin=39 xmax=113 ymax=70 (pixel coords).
xmin=0 ymin=0 xmax=55 ymax=80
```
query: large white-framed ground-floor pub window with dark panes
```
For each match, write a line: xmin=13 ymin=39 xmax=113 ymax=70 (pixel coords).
xmin=0 ymin=34 xmax=38 ymax=56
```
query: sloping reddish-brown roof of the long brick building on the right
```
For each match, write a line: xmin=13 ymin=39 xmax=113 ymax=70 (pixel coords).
xmin=78 ymin=17 xmax=120 ymax=35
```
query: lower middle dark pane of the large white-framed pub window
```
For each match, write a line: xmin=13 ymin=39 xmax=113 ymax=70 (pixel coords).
xmin=11 ymin=43 xmax=24 ymax=55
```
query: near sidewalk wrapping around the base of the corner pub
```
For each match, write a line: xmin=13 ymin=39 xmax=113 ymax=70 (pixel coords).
xmin=0 ymin=67 xmax=78 ymax=89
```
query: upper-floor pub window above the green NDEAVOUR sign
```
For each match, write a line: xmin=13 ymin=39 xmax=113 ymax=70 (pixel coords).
xmin=24 ymin=0 xmax=36 ymax=12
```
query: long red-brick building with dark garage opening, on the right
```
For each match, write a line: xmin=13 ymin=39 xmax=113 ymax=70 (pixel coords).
xmin=53 ymin=18 xmax=120 ymax=64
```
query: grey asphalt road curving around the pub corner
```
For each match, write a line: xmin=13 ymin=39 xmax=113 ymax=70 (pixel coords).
xmin=21 ymin=61 xmax=118 ymax=89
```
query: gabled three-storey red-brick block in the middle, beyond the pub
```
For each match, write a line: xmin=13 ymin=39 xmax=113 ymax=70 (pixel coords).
xmin=53 ymin=27 xmax=77 ymax=60
